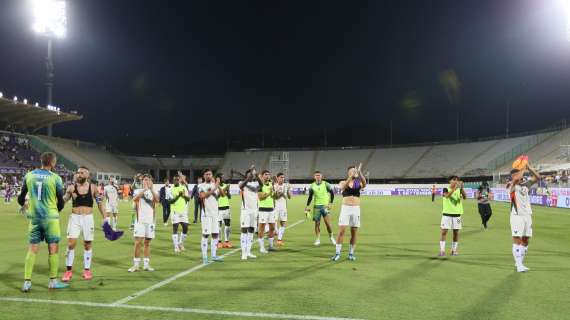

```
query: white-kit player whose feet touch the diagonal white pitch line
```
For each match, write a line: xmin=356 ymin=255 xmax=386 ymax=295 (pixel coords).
xmin=198 ymin=169 xmax=222 ymax=264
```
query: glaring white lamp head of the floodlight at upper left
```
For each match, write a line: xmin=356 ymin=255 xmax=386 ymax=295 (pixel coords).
xmin=32 ymin=0 xmax=67 ymax=38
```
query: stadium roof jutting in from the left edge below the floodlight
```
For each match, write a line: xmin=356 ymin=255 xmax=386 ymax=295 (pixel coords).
xmin=0 ymin=98 xmax=83 ymax=132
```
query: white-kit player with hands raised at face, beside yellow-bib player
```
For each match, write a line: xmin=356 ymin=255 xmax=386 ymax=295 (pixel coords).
xmin=239 ymin=167 xmax=261 ymax=260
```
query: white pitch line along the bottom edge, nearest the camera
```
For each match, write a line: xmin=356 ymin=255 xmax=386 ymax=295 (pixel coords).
xmin=0 ymin=297 xmax=360 ymax=320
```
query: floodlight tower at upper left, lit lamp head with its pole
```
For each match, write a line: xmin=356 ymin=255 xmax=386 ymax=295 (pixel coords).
xmin=32 ymin=0 xmax=67 ymax=136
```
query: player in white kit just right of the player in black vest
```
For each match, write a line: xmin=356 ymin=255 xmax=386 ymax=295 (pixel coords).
xmin=128 ymin=174 xmax=160 ymax=272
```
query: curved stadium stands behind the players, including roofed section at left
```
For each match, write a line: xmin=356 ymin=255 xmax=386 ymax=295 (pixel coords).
xmin=0 ymin=91 xmax=570 ymax=182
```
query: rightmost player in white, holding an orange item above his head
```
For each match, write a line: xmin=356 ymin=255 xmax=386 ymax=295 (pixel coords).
xmin=507 ymin=165 xmax=540 ymax=272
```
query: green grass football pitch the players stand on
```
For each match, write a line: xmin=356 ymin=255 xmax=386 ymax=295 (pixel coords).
xmin=0 ymin=197 xmax=570 ymax=320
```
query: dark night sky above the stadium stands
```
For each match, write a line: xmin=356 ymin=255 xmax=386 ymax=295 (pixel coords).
xmin=0 ymin=0 xmax=570 ymax=154
